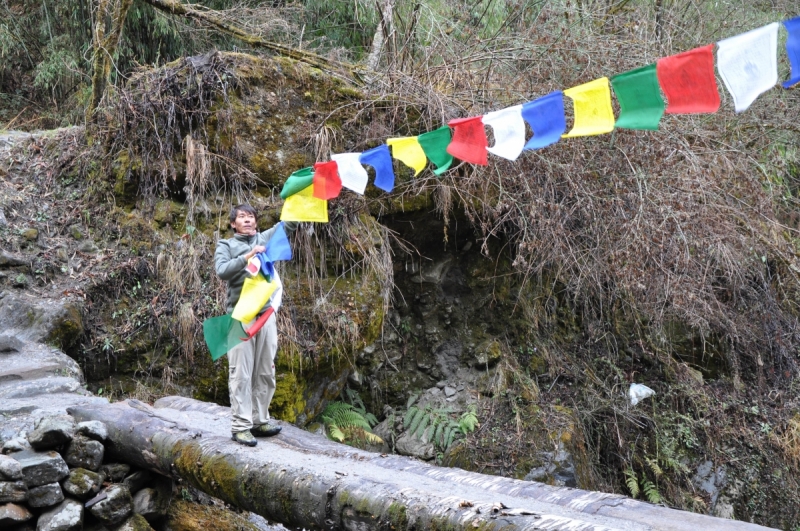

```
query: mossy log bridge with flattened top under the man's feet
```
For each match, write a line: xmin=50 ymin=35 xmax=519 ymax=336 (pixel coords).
xmin=68 ymin=397 xmax=768 ymax=531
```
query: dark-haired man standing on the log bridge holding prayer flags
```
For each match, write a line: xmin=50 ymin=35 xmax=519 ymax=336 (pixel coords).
xmin=214 ymin=204 xmax=297 ymax=446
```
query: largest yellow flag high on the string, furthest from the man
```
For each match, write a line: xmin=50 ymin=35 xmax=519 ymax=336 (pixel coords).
xmin=564 ymin=77 xmax=614 ymax=138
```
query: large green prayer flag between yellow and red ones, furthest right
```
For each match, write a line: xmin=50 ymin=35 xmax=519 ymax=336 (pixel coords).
xmin=611 ymin=63 xmax=665 ymax=129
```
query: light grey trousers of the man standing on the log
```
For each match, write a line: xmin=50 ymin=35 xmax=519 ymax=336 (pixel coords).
xmin=228 ymin=315 xmax=278 ymax=433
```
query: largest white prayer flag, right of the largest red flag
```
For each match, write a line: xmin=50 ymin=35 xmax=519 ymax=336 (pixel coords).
xmin=717 ymin=22 xmax=780 ymax=112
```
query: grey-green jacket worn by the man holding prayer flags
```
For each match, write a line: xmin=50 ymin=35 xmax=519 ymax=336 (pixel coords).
xmin=214 ymin=221 xmax=297 ymax=313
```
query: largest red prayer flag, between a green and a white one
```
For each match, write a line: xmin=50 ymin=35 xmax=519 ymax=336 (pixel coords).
xmin=656 ymin=44 xmax=720 ymax=114
